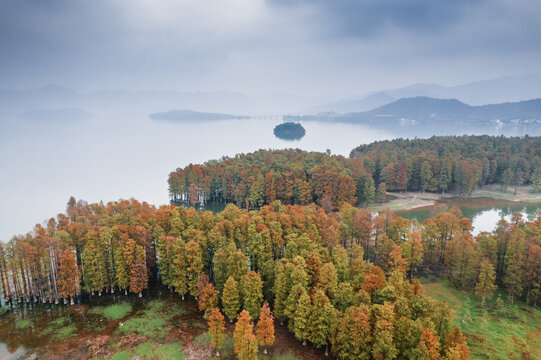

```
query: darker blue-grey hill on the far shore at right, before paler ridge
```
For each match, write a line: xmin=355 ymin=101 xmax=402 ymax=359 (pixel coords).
xmin=286 ymin=96 xmax=541 ymax=126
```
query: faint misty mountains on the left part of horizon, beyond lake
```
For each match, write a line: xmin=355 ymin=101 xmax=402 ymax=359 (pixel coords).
xmin=0 ymin=84 xmax=315 ymax=114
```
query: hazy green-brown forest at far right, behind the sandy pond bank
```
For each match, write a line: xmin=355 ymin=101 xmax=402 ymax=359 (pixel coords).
xmin=350 ymin=135 xmax=541 ymax=194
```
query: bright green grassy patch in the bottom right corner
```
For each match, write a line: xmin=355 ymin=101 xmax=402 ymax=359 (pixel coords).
xmin=423 ymin=281 xmax=541 ymax=360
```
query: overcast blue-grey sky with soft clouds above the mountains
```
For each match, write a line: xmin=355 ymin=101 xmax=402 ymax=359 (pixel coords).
xmin=0 ymin=0 xmax=541 ymax=97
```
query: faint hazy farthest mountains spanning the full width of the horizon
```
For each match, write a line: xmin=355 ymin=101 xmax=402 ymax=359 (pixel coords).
xmin=0 ymin=75 xmax=541 ymax=115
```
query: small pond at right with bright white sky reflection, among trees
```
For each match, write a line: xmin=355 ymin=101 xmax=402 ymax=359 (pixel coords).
xmin=397 ymin=198 xmax=541 ymax=235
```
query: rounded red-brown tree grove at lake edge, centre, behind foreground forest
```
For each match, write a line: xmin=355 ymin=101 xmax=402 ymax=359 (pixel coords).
xmin=168 ymin=149 xmax=375 ymax=210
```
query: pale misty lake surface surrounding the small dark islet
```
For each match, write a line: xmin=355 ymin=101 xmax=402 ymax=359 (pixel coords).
xmin=0 ymin=108 xmax=536 ymax=241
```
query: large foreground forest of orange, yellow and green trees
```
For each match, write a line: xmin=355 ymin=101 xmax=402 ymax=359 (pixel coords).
xmin=0 ymin=198 xmax=541 ymax=359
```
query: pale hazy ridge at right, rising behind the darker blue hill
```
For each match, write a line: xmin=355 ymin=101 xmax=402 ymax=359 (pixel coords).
xmin=305 ymin=75 xmax=541 ymax=114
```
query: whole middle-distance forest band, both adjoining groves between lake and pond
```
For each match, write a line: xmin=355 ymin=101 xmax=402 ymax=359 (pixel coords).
xmin=168 ymin=136 xmax=541 ymax=211
